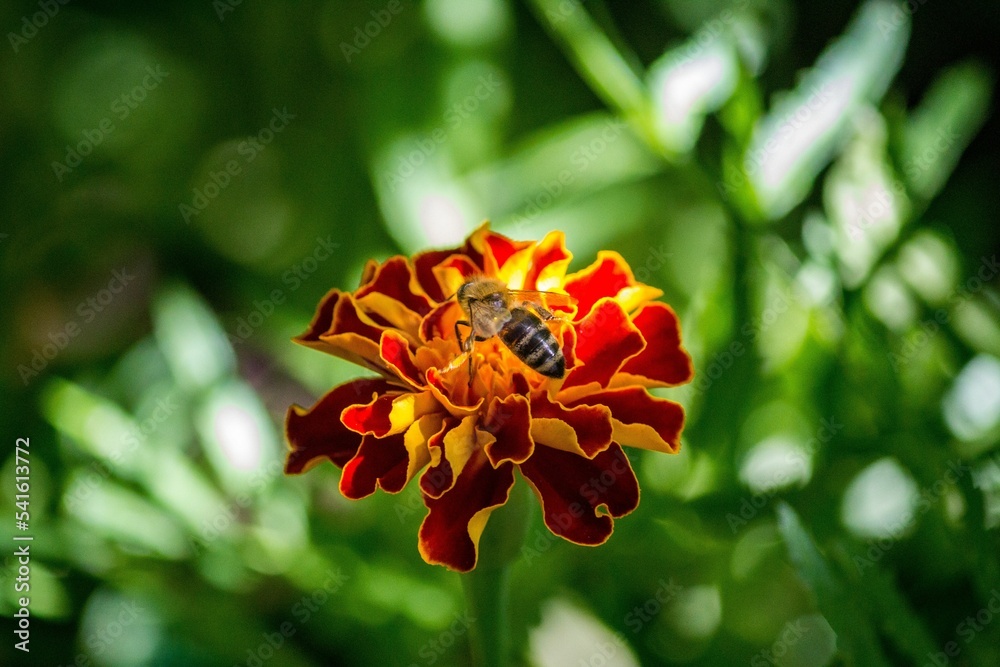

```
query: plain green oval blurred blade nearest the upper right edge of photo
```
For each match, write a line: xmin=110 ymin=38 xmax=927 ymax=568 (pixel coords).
xmin=900 ymin=62 xmax=993 ymax=200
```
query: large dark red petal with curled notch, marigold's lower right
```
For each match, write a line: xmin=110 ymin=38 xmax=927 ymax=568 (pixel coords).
xmin=521 ymin=443 xmax=639 ymax=545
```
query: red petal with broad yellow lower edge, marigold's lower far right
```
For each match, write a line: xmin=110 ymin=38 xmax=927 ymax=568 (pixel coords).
xmin=573 ymin=386 xmax=684 ymax=454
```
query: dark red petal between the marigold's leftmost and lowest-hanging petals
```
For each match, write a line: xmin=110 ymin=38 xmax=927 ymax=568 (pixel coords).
xmin=340 ymin=414 xmax=443 ymax=500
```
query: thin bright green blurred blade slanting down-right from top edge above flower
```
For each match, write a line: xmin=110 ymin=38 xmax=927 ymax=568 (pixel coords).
xmin=531 ymin=0 xmax=658 ymax=153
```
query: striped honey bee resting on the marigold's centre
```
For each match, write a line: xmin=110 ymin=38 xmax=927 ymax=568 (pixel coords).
xmin=455 ymin=276 xmax=574 ymax=386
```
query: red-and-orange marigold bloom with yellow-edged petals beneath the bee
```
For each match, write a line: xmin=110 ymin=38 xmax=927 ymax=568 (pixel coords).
xmin=285 ymin=224 xmax=692 ymax=572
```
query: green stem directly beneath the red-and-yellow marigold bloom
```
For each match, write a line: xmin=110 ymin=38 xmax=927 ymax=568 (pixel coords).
xmin=462 ymin=474 xmax=531 ymax=667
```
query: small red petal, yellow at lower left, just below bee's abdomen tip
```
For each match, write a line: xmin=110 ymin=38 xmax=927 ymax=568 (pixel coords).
xmin=531 ymin=392 xmax=612 ymax=459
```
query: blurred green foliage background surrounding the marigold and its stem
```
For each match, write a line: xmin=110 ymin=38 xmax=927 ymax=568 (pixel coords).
xmin=0 ymin=0 xmax=1000 ymax=667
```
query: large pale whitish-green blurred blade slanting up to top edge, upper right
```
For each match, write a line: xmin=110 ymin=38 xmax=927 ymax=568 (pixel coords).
xmin=741 ymin=0 xmax=910 ymax=220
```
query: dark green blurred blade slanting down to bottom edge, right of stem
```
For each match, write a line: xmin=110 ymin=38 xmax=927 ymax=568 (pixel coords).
xmin=777 ymin=502 xmax=889 ymax=667
